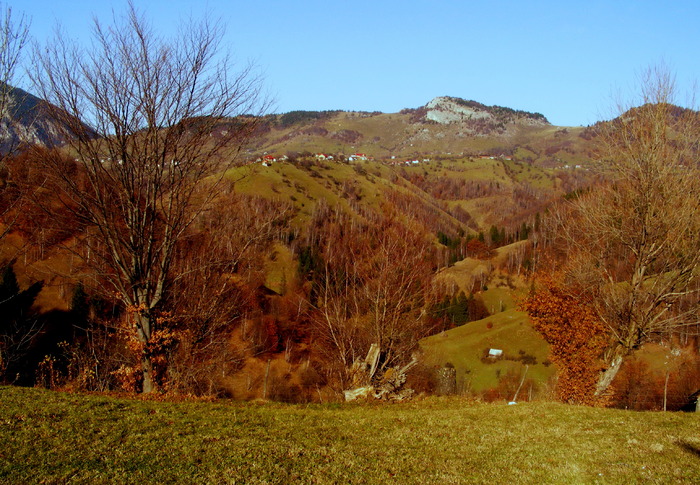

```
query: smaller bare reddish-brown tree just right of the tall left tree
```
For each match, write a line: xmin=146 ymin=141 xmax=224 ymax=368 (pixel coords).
xmin=167 ymin=191 xmax=291 ymax=395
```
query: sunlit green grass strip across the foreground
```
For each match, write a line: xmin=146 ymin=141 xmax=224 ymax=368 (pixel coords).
xmin=0 ymin=387 xmax=700 ymax=484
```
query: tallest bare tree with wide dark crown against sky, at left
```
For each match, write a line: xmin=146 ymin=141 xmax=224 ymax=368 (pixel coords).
xmin=33 ymin=3 xmax=261 ymax=392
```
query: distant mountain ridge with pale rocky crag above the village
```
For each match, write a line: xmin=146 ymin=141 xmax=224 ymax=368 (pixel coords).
xmin=248 ymin=96 xmax=591 ymax=167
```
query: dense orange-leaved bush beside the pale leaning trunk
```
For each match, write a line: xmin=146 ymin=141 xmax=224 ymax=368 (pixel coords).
xmin=521 ymin=277 xmax=607 ymax=405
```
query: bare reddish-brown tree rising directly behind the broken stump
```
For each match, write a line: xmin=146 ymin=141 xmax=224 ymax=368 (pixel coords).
xmin=315 ymin=208 xmax=433 ymax=384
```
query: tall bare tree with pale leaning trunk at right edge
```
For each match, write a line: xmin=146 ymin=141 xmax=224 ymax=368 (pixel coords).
xmin=558 ymin=69 xmax=700 ymax=394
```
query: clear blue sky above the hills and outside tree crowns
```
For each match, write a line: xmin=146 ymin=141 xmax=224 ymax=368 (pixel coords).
xmin=9 ymin=0 xmax=700 ymax=126
